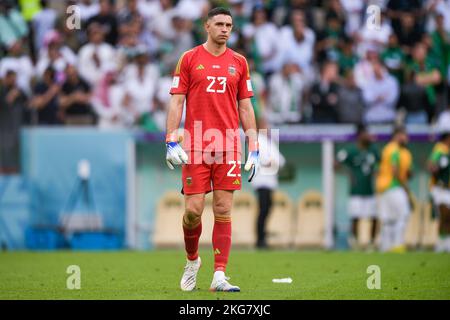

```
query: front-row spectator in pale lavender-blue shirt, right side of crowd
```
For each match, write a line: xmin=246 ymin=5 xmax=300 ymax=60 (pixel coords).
xmin=362 ymin=59 xmax=400 ymax=124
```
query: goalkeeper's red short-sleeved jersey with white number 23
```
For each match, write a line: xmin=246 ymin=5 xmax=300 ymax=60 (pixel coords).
xmin=170 ymin=45 xmax=253 ymax=152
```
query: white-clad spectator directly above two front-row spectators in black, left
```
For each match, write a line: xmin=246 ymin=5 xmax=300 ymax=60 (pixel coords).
xmin=36 ymin=30 xmax=78 ymax=78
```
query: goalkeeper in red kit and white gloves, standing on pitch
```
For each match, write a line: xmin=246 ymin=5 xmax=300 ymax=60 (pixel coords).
xmin=166 ymin=8 xmax=259 ymax=292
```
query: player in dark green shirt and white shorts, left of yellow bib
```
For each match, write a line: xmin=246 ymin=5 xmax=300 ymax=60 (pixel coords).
xmin=337 ymin=125 xmax=380 ymax=250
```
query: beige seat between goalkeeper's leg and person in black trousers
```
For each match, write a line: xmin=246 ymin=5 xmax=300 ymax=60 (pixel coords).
xmin=231 ymin=191 xmax=258 ymax=248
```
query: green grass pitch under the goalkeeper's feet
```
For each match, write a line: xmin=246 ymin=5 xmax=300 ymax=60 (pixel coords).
xmin=0 ymin=250 xmax=450 ymax=300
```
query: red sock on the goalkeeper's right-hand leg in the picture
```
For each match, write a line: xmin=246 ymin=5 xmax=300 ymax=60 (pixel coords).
xmin=213 ymin=217 xmax=231 ymax=272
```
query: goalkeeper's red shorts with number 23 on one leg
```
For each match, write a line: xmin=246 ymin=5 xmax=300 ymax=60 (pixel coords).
xmin=181 ymin=151 xmax=242 ymax=195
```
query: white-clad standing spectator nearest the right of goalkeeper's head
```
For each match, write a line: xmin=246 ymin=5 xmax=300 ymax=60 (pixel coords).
xmin=242 ymin=6 xmax=281 ymax=75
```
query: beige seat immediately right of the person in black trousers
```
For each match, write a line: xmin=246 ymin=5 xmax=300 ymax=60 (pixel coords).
xmin=266 ymin=191 xmax=294 ymax=248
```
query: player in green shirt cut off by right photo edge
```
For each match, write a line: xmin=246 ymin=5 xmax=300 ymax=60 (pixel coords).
xmin=428 ymin=127 xmax=450 ymax=252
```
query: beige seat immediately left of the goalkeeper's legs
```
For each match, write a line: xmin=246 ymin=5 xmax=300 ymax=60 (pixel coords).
xmin=153 ymin=191 xmax=184 ymax=248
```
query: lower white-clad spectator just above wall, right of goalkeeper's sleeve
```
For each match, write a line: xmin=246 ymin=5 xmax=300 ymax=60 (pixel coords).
xmin=267 ymin=61 xmax=306 ymax=124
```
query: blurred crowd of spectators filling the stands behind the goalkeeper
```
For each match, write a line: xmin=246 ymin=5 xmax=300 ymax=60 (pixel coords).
xmin=0 ymin=0 xmax=450 ymax=132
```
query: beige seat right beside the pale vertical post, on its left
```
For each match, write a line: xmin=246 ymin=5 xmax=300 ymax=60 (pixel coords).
xmin=294 ymin=191 xmax=325 ymax=248
